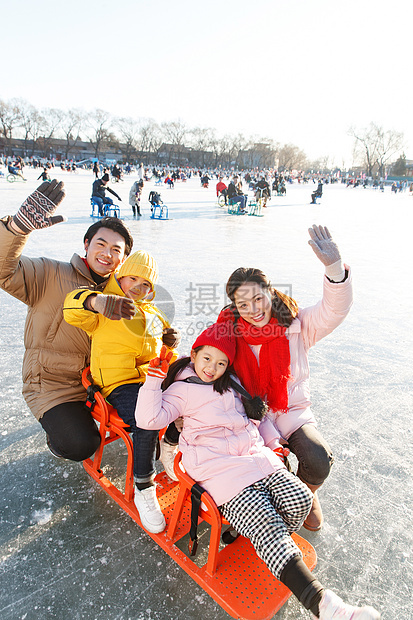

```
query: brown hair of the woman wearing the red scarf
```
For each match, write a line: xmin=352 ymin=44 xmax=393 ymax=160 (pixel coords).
xmin=224 ymin=267 xmax=298 ymax=327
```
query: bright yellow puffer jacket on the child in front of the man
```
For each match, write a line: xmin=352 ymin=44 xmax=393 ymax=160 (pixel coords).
xmin=63 ymin=274 xmax=176 ymax=398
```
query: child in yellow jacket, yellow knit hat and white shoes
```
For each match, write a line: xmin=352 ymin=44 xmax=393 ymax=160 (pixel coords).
xmin=63 ymin=250 xmax=179 ymax=533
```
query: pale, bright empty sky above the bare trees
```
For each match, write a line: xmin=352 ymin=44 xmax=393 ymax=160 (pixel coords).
xmin=0 ymin=0 xmax=413 ymax=166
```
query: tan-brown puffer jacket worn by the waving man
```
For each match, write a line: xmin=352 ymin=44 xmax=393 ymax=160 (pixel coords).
xmin=0 ymin=217 xmax=108 ymax=420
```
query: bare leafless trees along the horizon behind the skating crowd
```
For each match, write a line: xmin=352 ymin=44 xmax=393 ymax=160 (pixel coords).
xmin=0 ymin=99 xmax=403 ymax=176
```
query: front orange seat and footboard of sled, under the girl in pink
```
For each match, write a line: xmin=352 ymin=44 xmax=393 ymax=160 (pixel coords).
xmin=166 ymin=453 xmax=317 ymax=620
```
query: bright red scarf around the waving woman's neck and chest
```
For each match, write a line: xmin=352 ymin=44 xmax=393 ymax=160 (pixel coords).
xmin=233 ymin=317 xmax=291 ymax=412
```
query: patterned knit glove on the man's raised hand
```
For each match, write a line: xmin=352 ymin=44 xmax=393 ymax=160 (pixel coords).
xmin=13 ymin=179 xmax=66 ymax=234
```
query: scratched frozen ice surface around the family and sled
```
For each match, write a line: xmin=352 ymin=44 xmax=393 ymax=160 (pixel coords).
xmin=0 ymin=170 xmax=413 ymax=620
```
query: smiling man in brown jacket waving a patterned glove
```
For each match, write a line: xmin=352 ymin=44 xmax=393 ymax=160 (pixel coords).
xmin=0 ymin=180 xmax=133 ymax=461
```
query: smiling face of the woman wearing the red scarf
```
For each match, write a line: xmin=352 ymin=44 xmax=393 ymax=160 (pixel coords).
xmin=234 ymin=282 xmax=271 ymax=327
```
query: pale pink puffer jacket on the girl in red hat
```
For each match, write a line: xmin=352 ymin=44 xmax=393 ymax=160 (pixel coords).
xmin=136 ymin=366 xmax=284 ymax=506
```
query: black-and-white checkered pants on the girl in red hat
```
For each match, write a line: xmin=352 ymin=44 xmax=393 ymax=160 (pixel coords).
xmin=220 ymin=469 xmax=313 ymax=579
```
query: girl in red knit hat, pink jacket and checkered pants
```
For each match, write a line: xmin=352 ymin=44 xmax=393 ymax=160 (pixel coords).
xmin=136 ymin=323 xmax=380 ymax=620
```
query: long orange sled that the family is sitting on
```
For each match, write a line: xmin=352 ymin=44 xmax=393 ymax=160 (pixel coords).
xmin=82 ymin=368 xmax=317 ymax=620
